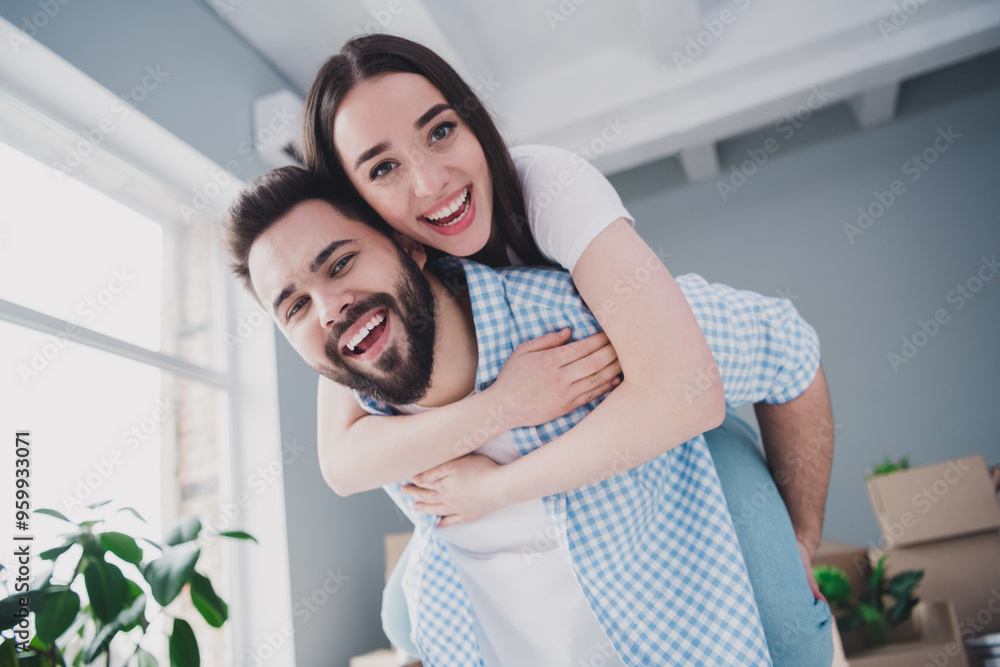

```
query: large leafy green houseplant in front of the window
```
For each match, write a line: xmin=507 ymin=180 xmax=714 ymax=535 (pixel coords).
xmin=0 ymin=502 xmax=256 ymax=667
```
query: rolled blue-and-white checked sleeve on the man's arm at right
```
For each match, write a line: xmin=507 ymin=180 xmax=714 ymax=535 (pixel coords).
xmin=677 ymin=274 xmax=820 ymax=405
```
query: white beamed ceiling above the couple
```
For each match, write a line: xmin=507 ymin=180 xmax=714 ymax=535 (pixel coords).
xmin=211 ymin=0 xmax=1000 ymax=178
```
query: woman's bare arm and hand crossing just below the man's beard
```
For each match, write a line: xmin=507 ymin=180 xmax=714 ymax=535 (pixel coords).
xmin=317 ymin=329 xmax=621 ymax=496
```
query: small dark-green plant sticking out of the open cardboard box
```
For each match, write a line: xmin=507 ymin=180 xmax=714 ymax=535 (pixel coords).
xmin=813 ymin=556 xmax=924 ymax=646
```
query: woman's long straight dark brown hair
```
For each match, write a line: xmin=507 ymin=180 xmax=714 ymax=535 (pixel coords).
xmin=302 ymin=34 xmax=551 ymax=265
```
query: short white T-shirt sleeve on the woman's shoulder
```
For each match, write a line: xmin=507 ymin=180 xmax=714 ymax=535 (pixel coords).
xmin=510 ymin=145 xmax=635 ymax=272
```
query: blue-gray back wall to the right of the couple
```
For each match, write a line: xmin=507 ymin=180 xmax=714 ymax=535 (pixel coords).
xmin=611 ymin=52 xmax=1000 ymax=544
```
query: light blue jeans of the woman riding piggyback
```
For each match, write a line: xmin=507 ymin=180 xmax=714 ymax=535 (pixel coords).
xmin=382 ymin=412 xmax=833 ymax=667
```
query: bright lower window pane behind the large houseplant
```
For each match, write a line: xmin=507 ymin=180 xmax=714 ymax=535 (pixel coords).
xmin=0 ymin=321 xmax=232 ymax=665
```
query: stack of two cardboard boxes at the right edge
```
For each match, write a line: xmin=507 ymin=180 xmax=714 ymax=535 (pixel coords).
xmin=868 ymin=456 xmax=1000 ymax=638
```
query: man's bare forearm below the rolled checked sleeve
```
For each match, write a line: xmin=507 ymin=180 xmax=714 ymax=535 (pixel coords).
xmin=754 ymin=366 xmax=835 ymax=597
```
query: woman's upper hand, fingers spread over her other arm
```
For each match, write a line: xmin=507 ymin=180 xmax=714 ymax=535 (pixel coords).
xmin=484 ymin=329 xmax=622 ymax=426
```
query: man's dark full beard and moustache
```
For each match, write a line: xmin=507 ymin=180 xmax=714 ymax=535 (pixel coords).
xmin=316 ymin=250 xmax=435 ymax=405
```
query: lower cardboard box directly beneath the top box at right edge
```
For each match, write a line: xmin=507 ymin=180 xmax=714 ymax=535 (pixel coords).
xmin=870 ymin=530 xmax=1000 ymax=637
